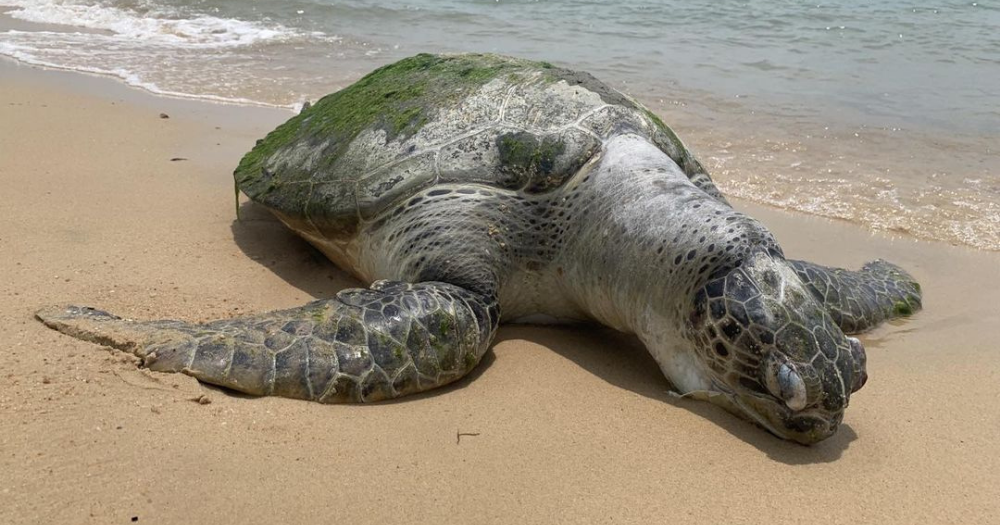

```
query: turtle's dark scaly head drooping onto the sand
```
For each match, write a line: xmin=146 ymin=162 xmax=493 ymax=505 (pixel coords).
xmin=689 ymin=251 xmax=867 ymax=444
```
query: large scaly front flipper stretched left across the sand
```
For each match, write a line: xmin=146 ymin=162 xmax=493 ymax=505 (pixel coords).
xmin=36 ymin=281 xmax=500 ymax=403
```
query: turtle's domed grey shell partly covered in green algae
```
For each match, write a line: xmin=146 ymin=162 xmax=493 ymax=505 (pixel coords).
xmin=234 ymin=51 xmax=722 ymax=238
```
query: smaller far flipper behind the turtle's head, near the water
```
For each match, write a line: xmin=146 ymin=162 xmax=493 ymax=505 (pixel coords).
xmin=788 ymin=259 xmax=922 ymax=334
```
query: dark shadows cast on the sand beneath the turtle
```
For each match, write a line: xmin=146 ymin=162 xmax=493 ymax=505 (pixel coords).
xmin=227 ymin=202 xmax=857 ymax=465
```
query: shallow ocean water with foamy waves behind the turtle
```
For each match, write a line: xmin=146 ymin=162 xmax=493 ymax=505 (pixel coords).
xmin=0 ymin=0 xmax=1000 ymax=250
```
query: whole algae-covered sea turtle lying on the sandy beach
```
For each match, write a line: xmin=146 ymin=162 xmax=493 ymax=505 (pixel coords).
xmin=38 ymin=54 xmax=921 ymax=444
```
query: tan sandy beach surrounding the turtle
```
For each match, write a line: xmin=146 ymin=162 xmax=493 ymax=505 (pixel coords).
xmin=0 ymin=62 xmax=1000 ymax=524
